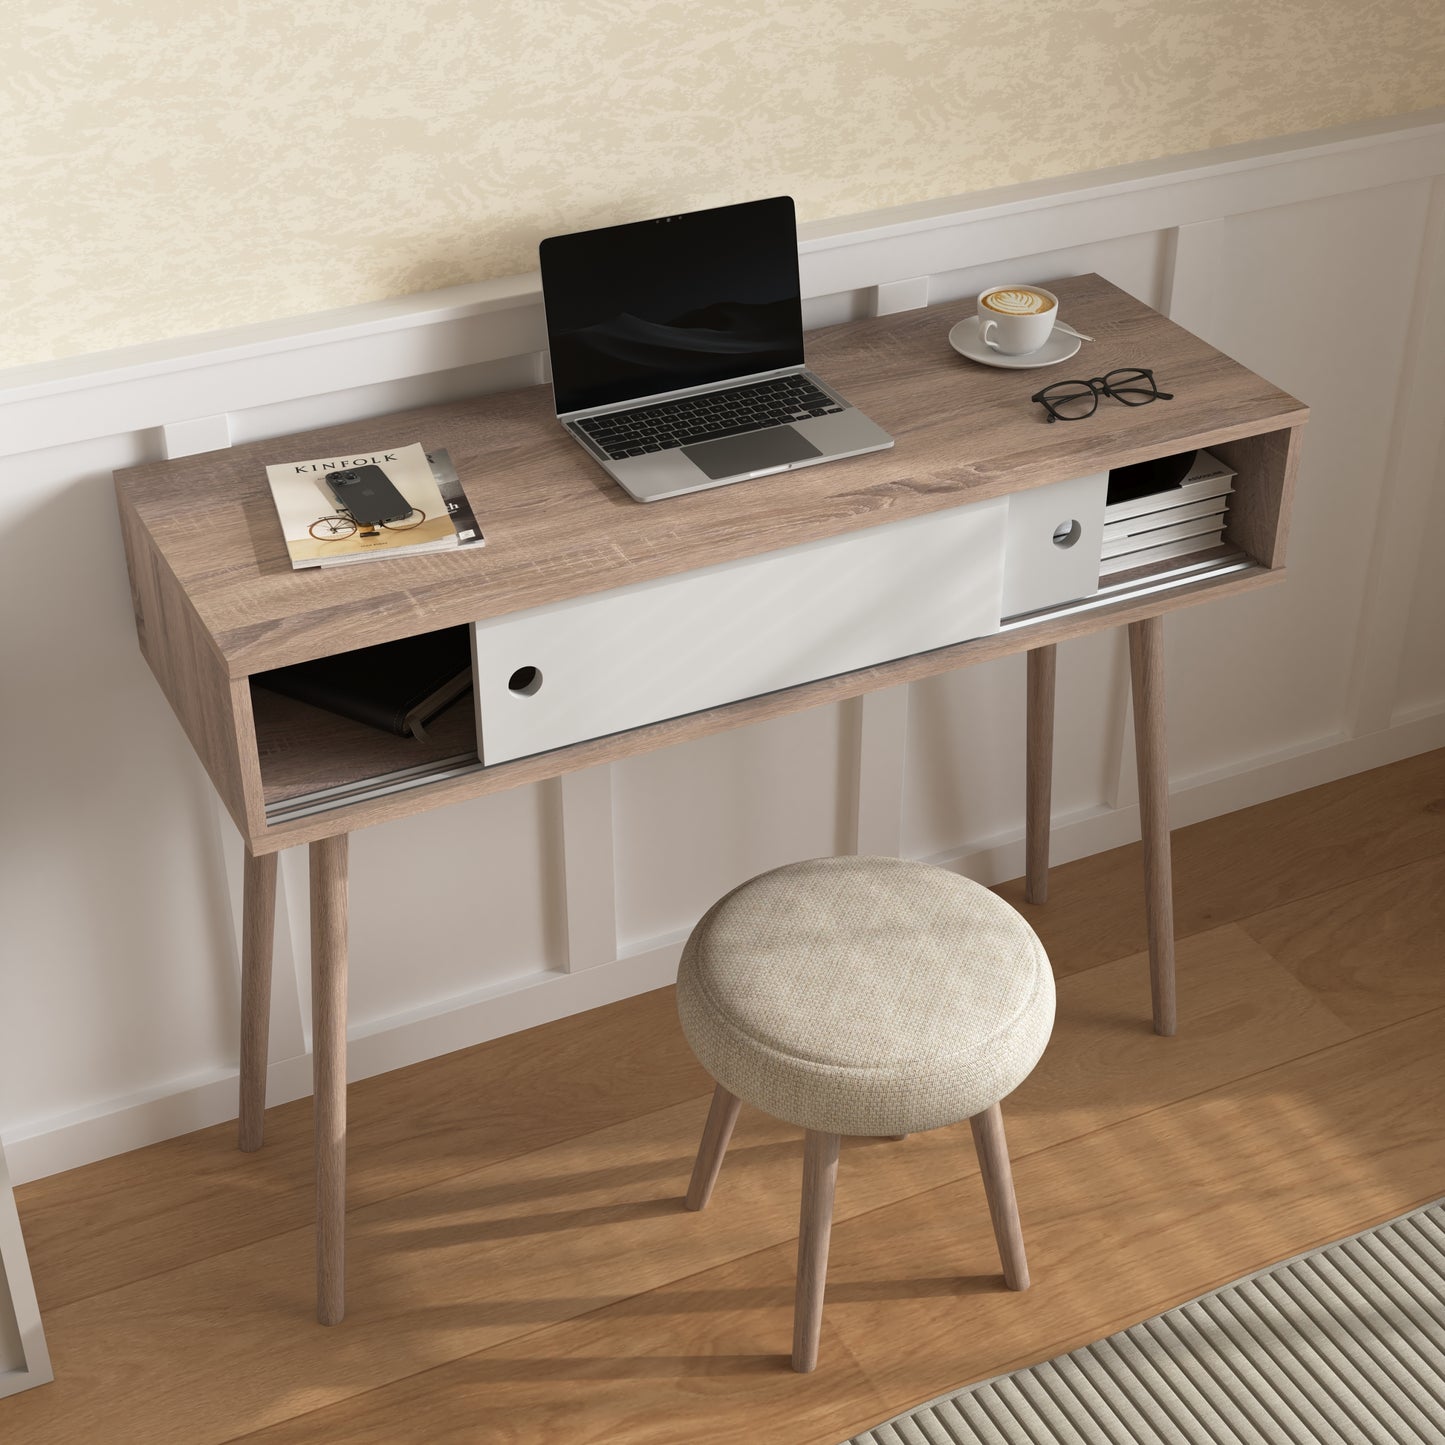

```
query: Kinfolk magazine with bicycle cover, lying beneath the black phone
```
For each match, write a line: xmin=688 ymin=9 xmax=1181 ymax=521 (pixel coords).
xmin=266 ymin=442 xmax=458 ymax=568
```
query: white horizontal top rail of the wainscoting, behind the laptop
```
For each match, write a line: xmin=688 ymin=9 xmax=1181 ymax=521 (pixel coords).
xmin=0 ymin=108 xmax=1445 ymax=455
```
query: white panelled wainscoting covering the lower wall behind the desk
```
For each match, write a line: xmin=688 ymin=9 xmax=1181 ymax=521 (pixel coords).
xmin=0 ymin=113 xmax=1445 ymax=1181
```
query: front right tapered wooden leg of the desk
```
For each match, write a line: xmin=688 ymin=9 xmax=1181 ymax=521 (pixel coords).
xmin=1129 ymin=617 xmax=1178 ymax=1035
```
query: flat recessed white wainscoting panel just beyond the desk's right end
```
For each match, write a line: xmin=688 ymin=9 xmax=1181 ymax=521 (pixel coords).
xmin=1156 ymin=182 xmax=1428 ymax=777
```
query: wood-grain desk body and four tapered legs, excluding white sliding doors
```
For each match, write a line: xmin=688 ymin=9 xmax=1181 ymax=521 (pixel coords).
xmin=116 ymin=276 xmax=1308 ymax=1324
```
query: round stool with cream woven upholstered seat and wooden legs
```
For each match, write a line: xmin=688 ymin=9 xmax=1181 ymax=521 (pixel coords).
xmin=678 ymin=858 xmax=1053 ymax=1371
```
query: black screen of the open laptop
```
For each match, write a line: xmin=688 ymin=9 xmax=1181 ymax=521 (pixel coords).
xmin=539 ymin=195 xmax=803 ymax=413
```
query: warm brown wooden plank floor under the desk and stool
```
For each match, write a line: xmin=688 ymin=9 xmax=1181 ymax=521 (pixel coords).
xmin=11 ymin=751 xmax=1445 ymax=1445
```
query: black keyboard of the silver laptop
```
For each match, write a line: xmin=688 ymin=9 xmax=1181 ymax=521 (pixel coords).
xmin=575 ymin=376 xmax=842 ymax=461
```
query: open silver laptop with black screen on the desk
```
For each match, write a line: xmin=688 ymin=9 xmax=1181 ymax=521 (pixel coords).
xmin=539 ymin=195 xmax=893 ymax=501
